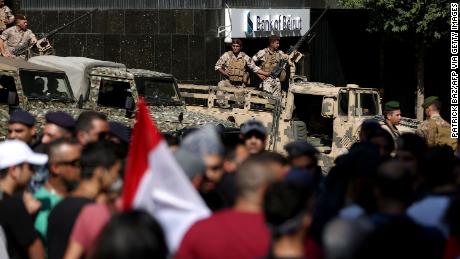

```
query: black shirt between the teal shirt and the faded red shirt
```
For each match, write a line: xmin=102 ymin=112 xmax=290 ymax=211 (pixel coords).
xmin=46 ymin=197 xmax=93 ymax=259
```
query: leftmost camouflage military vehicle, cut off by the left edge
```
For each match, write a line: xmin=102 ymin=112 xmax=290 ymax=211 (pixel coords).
xmin=0 ymin=57 xmax=79 ymax=138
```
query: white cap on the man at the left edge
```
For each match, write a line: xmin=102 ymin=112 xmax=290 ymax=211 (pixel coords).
xmin=0 ymin=140 xmax=48 ymax=169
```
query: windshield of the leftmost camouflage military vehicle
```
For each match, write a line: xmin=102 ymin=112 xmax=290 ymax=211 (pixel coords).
xmin=19 ymin=70 xmax=73 ymax=101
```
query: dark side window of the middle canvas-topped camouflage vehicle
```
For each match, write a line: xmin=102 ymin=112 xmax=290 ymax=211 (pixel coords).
xmin=97 ymin=79 xmax=132 ymax=109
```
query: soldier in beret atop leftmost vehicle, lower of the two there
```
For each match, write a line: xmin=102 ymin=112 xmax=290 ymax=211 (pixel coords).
xmin=0 ymin=14 xmax=37 ymax=59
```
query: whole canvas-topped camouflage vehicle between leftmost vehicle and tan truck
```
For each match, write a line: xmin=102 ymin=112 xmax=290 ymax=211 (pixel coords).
xmin=29 ymin=56 xmax=235 ymax=132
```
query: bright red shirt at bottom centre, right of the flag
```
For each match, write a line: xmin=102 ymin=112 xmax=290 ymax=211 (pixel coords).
xmin=176 ymin=209 xmax=270 ymax=259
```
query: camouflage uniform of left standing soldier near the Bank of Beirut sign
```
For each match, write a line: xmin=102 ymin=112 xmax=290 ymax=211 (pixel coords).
xmin=214 ymin=51 xmax=260 ymax=88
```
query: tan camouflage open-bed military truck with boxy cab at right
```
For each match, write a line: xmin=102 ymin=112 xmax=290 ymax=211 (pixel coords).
xmin=179 ymin=76 xmax=417 ymax=170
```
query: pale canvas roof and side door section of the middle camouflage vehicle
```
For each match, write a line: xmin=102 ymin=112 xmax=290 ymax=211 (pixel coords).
xmin=29 ymin=56 xmax=137 ymax=127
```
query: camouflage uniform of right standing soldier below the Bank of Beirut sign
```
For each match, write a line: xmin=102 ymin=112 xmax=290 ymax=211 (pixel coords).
xmin=252 ymin=48 xmax=288 ymax=96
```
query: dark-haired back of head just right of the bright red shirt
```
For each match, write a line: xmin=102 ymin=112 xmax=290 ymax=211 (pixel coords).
xmin=264 ymin=182 xmax=311 ymax=238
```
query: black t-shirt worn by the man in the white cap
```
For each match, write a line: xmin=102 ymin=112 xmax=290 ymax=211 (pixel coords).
xmin=0 ymin=191 xmax=38 ymax=259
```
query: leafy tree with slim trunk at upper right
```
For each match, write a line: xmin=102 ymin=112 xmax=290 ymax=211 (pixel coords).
xmin=338 ymin=0 xmax=450 ymax=120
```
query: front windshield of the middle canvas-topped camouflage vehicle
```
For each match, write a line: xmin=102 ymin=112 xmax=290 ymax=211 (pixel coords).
xmin=135 ymin=77 xmax=182 ymax=106
